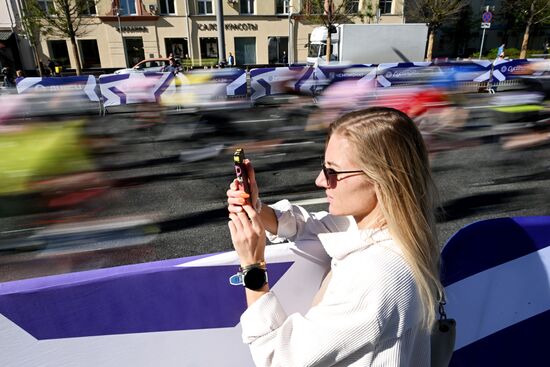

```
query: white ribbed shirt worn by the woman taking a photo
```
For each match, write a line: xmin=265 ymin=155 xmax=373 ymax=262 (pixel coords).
xmin=241 ymin=200 xmax=430 ymax=367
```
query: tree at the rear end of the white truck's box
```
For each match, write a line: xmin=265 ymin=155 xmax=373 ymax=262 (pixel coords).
xmin=406 ymin=0 xmax=470 ymax=60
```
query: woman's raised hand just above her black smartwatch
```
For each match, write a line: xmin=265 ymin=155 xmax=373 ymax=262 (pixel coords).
xmin=228 ymin=204 xmax=266 ymax=266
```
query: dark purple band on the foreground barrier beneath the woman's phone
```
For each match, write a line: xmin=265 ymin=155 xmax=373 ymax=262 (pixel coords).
xmin=0 ymin=259 xmax=292 ymax=340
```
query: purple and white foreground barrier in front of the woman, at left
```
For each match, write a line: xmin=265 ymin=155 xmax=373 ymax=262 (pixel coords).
xmin=0 ymin=242 xmax=330 ymax=367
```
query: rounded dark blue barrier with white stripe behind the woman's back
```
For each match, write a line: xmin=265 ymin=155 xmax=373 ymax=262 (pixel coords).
xmin=441 ymin=217 xmax=550 ymax=367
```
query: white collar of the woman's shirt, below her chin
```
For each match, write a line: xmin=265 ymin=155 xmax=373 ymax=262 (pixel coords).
xmin=318 ymin=224 xmax=393 ymax=260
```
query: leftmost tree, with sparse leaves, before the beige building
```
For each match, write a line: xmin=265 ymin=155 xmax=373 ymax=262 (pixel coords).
xmin=26 ymin=0 xmax=99 ymax=75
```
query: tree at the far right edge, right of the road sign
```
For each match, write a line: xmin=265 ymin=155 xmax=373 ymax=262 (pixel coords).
xmin=503 ymin=0 xmax=550 ymax=59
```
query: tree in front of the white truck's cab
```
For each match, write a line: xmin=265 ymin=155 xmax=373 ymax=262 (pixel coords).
xmin=301 ymin=0 xmax=370 ymax=61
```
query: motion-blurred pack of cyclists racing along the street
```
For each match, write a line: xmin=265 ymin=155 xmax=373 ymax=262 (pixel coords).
xmin=0 ymin=60 xmax=550 ymax=278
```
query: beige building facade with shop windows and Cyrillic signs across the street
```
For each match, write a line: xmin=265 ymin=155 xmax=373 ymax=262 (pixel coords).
xmin=34 ymin=0 xmax=404 ymax=69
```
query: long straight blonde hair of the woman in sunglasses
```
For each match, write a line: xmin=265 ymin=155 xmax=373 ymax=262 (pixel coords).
xmin=328 ymin=107 xmax=443 ymax=327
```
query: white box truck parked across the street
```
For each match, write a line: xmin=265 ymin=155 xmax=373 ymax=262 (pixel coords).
xmin=307 ymin=23 xmax=428 ymax=65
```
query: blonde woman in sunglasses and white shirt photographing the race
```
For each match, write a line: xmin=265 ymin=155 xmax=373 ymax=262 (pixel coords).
xmin=227 ymin=108 xmax=442 ymax=367
